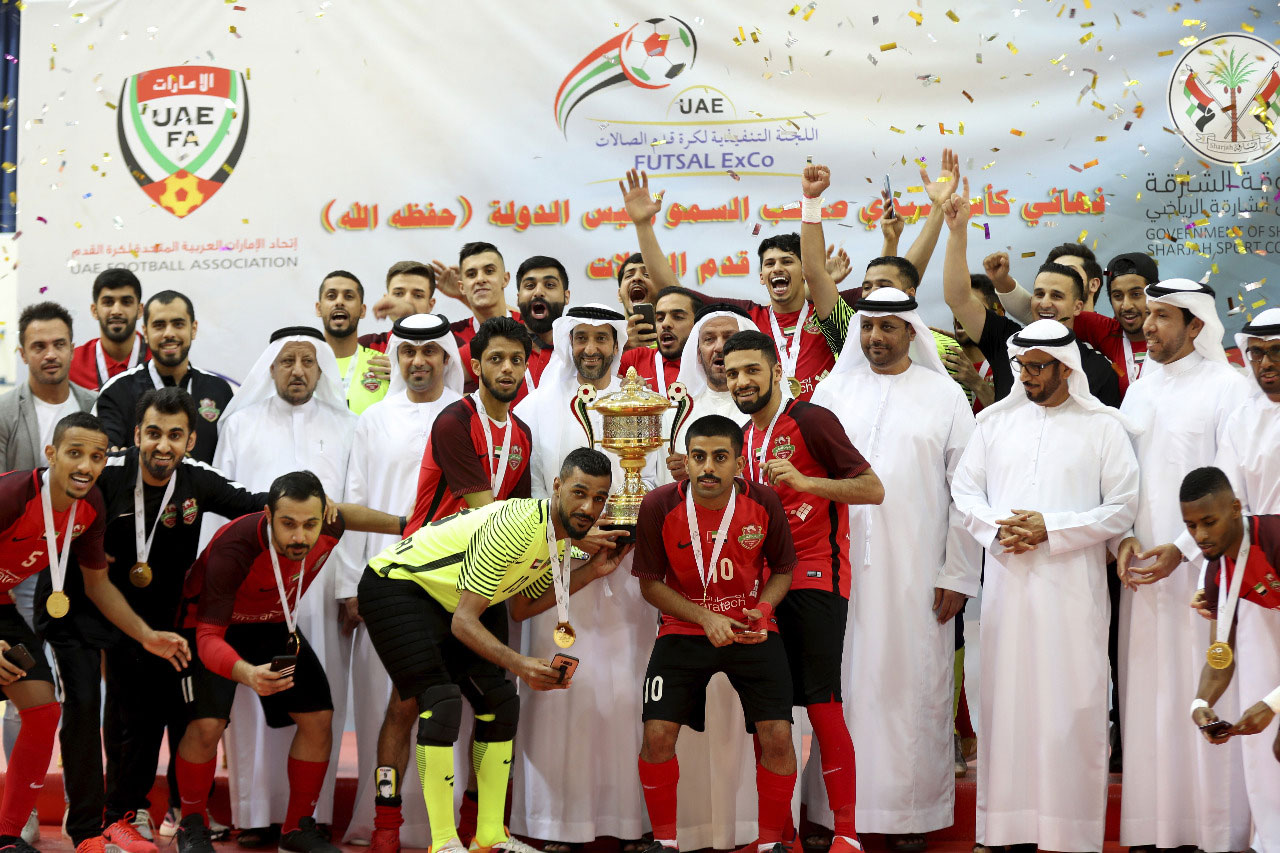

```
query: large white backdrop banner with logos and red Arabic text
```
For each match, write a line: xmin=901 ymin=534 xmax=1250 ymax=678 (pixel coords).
xmin=9 ymin=0 xmax=1280 ymax=379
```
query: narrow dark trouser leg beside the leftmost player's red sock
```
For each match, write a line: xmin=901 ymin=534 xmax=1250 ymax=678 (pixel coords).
xmin=50 ymin=643 xmax=105 ymax=844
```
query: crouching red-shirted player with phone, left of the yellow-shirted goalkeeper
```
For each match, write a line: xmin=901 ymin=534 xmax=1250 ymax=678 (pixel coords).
xmin=177 ymin=471 xmax=404 ymax=853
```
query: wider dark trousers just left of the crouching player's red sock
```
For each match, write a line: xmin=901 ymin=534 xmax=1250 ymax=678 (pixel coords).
xmin=104 ymin=640 xmax=187 ymax=825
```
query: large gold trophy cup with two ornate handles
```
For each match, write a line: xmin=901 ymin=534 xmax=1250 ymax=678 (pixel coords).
xmin=572 ymin=368 xmax=692 ymax=542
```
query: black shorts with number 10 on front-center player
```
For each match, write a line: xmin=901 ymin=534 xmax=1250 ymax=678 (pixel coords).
xmin=641 ymin=631 xmax=791 ymax=733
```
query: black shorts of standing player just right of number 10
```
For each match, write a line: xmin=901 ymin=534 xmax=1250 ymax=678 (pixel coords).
xmin=774 ymin=589 xmax=849 ymax=706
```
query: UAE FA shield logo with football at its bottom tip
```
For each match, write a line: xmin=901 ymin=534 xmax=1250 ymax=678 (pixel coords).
xmin=116 ymin=65 xmax=248 ymax=218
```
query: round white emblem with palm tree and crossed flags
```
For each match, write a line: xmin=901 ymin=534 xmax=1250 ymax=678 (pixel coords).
xmin=1169 ymin=33 xmax=1280 ymax=165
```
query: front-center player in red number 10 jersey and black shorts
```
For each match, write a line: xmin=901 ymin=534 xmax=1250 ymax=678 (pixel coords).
xmin=631 ymin=415 xmax=796 ymax=853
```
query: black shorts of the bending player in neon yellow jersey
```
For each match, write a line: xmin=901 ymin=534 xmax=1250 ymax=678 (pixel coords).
xmin=356 ymin=567 xmax=507 ymax=712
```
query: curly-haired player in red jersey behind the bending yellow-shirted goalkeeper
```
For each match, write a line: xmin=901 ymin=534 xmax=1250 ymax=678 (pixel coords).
xmin=406 ymin=316 xmax=532 ymax=533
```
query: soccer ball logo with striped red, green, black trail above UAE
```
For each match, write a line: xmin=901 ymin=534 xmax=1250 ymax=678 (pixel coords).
xmin=554 ymin=17 xmax=698 ymax=131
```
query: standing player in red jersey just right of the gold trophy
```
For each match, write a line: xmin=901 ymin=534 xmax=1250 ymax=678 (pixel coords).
xmin=724 ymin=332 xmax=884 ymax=853
